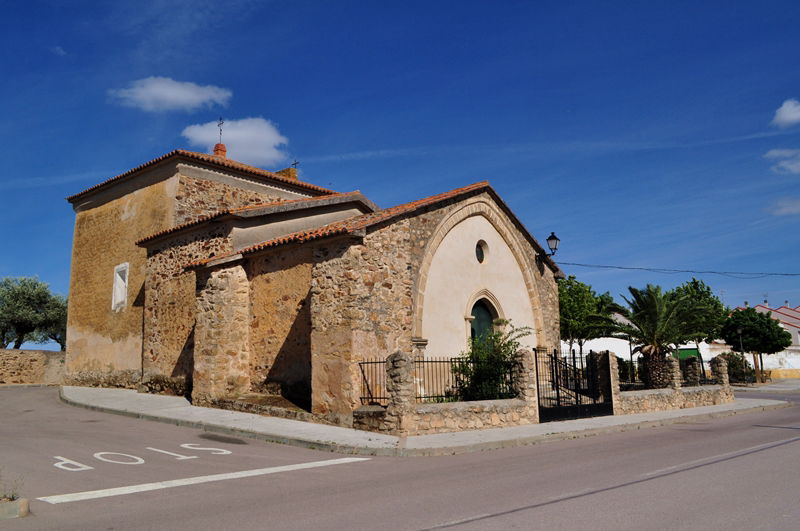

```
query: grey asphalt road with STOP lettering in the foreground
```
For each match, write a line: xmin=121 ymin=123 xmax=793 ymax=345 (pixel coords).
xmin=0 ymin=388 xmax=800 ymax=530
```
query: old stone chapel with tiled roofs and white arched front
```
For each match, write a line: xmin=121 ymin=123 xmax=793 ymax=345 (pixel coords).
xmin=66 ymin=144 xmax=562 ymax=425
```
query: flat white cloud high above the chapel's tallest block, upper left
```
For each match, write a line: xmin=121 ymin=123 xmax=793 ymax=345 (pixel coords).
xmin=108 ymin=77 xmax=233 ymax=112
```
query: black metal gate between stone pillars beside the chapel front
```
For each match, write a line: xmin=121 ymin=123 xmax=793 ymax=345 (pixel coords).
xmin=536 ymin=350 xmax=612 ymax=422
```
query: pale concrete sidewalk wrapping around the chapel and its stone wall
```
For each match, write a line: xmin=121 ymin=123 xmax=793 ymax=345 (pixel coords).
xmin=60 ymin=386 xmax=790 ymax=456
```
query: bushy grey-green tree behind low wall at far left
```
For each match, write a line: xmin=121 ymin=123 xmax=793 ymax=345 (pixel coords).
xmin=0 ymin=277 xmax=66 ymax=349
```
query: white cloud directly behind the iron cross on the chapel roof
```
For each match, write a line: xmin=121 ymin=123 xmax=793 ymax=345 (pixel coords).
xmin=181 ymin=118 xmax=289 ymax=166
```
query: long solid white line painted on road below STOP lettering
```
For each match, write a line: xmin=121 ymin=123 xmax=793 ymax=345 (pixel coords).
xmin=36 ymin=457 xmax=369 ymax=503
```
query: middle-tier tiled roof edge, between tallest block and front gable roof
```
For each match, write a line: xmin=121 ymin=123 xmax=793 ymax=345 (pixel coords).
xmin=136 ymin=190 xmax=377 ymax=245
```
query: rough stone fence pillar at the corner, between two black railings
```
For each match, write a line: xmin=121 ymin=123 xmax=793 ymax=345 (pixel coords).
xmin=384 ymin=351 xmax=416 ymax=437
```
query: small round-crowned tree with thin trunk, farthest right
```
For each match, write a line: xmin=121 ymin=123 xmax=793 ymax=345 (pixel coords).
xmin=720 ymin=308 xmax=792 ymax=381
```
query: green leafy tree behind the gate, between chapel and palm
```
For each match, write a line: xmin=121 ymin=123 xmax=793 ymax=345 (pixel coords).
xmin=558 ymin=275 xmax=614 ymax=355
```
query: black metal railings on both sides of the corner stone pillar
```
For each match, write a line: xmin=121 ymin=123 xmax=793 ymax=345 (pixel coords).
xmin=358 ymin=358 xmax=517 ymax=406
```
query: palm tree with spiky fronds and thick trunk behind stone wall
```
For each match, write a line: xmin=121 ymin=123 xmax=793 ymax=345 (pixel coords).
xmin=607 ymin=284 xmax=698 ymax=388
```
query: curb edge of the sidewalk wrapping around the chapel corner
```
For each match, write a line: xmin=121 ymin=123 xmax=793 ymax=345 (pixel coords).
xmin=58 ymin=387 xmax=793 ymax=457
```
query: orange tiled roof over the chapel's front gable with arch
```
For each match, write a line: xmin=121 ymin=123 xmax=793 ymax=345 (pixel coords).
xmin=185 ymin=181 xmax=560 ymax=272
